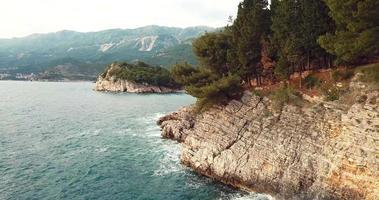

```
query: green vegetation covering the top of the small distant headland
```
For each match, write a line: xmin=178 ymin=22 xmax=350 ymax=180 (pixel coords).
xmin=101 ymin=62 xmax=180 ymax=88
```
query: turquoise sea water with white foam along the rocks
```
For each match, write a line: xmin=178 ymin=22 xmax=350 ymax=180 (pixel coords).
xmin=0 ymin=81 xmax=265 ymax=200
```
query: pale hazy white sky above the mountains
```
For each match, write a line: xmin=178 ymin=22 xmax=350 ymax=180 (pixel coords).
xmin=0 ymin=0 xmax=241 ymax=38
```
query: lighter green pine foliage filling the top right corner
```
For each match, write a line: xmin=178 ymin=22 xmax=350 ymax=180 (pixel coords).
xmin=319 ymin=0 xmax=379 ymax=62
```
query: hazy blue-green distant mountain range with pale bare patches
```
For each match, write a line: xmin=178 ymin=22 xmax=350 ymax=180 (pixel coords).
xmin=0 ymin=26 xmax=215 ymax=80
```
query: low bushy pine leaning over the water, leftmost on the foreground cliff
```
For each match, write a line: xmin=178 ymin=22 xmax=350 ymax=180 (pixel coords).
xmin=171 ymin=32 xmax=241 ymax=110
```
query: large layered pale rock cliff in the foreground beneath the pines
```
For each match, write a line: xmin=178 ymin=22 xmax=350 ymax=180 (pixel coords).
xmin=158 ymin=77 xmax=379 ymax=200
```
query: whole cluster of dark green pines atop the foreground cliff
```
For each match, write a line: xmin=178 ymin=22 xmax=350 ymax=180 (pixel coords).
xmin=172 ymin=0 xmax=379 ymax=107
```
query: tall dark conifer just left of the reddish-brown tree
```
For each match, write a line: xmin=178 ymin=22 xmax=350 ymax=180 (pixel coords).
xmin=230 ymin=0 xmax=271 ymax=84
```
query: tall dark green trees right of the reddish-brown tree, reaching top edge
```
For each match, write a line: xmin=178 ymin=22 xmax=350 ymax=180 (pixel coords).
xmin=271 ymin=0 xmax=334 ymax=81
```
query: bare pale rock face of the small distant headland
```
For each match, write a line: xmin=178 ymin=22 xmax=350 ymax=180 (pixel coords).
xmin=95 ymin=63 xmax=179 ymax=93
